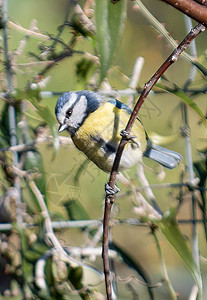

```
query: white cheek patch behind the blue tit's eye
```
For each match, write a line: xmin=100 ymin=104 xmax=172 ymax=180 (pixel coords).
xmin=70 ymin=96 xmax=87 ymax=128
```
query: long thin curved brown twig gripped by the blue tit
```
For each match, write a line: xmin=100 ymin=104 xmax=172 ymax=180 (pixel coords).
xmin=102 ymin=24 xmax=205 ymax=300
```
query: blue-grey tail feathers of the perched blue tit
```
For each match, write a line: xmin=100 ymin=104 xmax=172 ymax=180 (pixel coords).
xmin=144 ymin=143 xmax=182 ymax=169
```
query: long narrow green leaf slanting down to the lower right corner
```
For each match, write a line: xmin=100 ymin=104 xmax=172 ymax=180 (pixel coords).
xmin=159 ymin=210 xmax=202 ymax=295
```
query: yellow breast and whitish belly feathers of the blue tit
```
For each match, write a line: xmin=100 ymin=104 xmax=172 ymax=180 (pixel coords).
xmin=72 ymin=102 xmax=147 ymax=172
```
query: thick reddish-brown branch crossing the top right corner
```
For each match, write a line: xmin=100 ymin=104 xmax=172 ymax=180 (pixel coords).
xmin=161 ymin=0 xmax=207 ymax=26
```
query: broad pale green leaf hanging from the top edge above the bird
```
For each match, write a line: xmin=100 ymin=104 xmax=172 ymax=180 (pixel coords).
xmin=95 ymin=0 xmax=126 ymax=82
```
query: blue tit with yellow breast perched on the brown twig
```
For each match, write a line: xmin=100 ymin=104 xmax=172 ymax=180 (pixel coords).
xmin=55 ymin=90 xmax=182 ymax=172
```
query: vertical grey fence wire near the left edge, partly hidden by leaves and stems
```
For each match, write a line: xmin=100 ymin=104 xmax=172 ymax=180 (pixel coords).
xmin=2 ymin=0 xmax=22 ymax=224
